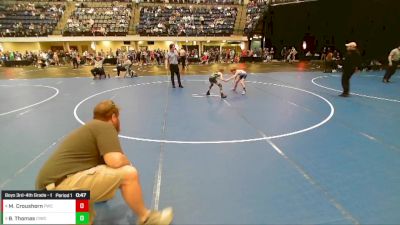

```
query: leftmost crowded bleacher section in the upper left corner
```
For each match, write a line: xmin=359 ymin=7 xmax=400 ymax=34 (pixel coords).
xmin=0 ymin=2 xmax=65 ymax=37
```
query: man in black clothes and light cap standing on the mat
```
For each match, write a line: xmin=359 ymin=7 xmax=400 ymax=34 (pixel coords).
xmin=339 ymin=42 xmax=361 ymax=97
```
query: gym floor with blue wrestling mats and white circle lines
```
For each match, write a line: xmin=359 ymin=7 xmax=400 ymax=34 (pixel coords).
xmin=0 ymin=63 xmax=400 ymax=224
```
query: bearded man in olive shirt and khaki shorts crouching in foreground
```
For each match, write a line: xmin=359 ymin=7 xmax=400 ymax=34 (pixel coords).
xmin=36 ymin=100 xmax=173 ymax=225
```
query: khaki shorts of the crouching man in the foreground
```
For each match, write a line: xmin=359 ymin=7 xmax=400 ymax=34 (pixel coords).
xmin=46 ymin=165 xmax=132 ymax=224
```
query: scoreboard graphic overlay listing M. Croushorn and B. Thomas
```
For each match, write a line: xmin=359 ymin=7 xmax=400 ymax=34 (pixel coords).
xmin=1 ymin=190 xmax=90 ymax=224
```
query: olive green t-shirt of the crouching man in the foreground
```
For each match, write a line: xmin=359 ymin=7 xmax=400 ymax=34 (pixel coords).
xmin=36 ymin=120 xmax=122 ymax=190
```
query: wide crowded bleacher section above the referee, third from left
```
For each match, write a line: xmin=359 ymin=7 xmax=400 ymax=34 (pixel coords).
xmin=137 ymin=5 xmax=237 ymax=36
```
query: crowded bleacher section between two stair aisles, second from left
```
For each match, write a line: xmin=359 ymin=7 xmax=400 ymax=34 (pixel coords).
xmin=63 ymin=3 xmax=132 ymax=36
